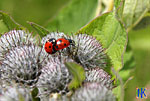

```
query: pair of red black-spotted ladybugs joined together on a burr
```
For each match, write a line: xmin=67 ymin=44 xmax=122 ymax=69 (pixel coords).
xmin=44 ymin=38 xmax=75 ymax=54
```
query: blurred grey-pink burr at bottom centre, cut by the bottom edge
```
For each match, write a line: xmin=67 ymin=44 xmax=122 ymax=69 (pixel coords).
xmin=71 ymin=83 xmax=115 ymax=101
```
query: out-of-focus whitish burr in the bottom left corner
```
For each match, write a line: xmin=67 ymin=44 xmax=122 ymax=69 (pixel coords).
xmin=0 ymin=84 xmax=32 ymax=101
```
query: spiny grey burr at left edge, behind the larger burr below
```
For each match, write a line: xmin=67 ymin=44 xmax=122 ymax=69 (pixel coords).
xmin=0 ymin=30 xmax=36 ymax=60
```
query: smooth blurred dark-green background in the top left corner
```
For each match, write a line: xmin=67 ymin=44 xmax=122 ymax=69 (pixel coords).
xmin=0 ymin=0 xmax=69 ymax=29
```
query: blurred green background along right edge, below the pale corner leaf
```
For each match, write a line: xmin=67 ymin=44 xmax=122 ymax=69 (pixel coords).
xmin=125 ymin=23 xmax=150 ymax=100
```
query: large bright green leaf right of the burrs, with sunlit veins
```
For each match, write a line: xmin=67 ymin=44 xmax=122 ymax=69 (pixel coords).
xmin=78 ymin=12 xmax=127 ymax=70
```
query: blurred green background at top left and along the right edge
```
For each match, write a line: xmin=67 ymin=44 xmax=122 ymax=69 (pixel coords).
xmin=0 ymin=0 xmax=150 ymax=101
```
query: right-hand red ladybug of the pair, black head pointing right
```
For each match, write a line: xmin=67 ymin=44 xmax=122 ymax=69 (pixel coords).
xmin=54 ymin=38 xmax=74 ymax=51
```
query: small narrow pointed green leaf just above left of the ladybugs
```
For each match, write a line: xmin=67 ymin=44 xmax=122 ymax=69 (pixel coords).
xmin=28 ymin=22 xmax=49 ymax=37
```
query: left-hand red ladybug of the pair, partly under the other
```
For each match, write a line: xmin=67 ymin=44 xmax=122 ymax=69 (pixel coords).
xmin=44 ymin=38 xmax=57 ymax=54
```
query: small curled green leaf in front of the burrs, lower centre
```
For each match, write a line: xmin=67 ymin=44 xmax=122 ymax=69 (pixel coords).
xmin=65 ymin=62 xmax=85 ymax=90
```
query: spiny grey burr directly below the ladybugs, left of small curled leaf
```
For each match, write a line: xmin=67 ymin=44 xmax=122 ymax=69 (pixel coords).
xmin=37 ymin=56 xmax=73 ymax=95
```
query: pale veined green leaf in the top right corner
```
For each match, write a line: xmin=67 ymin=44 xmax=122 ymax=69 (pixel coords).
xmin=123 ymin=0 xmax=150 ymax=31
